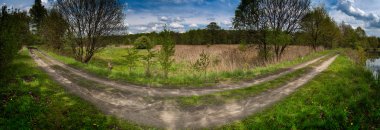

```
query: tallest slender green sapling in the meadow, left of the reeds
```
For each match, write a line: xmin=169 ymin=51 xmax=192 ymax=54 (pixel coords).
xmin=159 ymin=29 xmax=175 ymax=78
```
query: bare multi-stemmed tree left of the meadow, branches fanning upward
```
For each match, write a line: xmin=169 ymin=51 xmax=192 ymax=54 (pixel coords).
xmin=56 ymin=0 xmax=123 ymax=63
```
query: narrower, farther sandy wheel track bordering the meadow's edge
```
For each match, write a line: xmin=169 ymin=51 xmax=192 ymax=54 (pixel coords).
xmin=31 ymin=50 xmax=325 ymax=97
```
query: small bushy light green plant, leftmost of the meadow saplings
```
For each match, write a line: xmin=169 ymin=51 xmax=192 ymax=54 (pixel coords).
xmin=123 ymin=48 xmax=140 ymax=73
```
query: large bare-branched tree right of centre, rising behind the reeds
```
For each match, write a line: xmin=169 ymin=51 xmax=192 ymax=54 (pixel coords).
xmin=234 ymin=0 xmax=310 ymax=59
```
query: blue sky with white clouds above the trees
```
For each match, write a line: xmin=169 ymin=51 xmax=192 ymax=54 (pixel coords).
xmin=0 ymin=0 xmax=380 ymax=36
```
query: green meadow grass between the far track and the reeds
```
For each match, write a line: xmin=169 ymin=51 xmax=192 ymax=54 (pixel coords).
xmin=40 ymin=47 xmax=331 ymax=88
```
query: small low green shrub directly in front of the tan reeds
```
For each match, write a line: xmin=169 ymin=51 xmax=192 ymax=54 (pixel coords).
xmin=192 ymin=51 xmax=210 ymax=77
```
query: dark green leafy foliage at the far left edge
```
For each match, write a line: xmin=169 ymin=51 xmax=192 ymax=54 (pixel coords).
xmin=0 ymin=6 xmax=30 ymax=70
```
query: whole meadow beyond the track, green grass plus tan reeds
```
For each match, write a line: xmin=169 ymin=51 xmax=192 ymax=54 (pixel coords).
xmin=41 ymin=45 xmax=328 ymax=87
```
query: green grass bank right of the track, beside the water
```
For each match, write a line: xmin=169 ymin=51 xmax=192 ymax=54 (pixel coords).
xmin=220 ymin=56 xmax=380 ymax=129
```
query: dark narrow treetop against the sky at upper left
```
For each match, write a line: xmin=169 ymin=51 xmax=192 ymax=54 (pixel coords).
xmin=29 ymin=0 xmax=47 ymax=30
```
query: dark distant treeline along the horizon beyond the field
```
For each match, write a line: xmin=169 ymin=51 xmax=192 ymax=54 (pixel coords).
xmin=104 ymin=27 xmax=380 ymax=48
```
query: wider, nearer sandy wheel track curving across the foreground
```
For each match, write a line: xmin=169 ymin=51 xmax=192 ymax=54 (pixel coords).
xmin=30 ymin=48 xmax=337 ymax=129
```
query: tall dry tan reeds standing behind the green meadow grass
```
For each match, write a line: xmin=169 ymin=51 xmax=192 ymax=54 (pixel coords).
xmin=121 ymin=44 xmax=323 ymax=72
